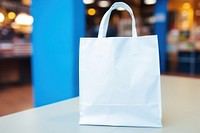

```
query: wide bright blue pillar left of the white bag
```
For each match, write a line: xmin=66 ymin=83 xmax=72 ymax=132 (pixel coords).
xmin=31 ymin=0 xmax=85 ymax=107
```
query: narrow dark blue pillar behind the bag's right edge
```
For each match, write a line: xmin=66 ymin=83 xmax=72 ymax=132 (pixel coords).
xmin=154 ymin=0 xmax=168 ymax=72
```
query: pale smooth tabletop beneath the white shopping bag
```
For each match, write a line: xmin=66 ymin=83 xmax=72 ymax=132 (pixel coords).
xmin=0 ymin=76 xmax=200 ymax=133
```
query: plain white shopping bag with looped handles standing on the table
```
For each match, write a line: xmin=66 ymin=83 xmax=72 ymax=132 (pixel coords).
xmin=79 ymin=2 xmax=162 ymax=127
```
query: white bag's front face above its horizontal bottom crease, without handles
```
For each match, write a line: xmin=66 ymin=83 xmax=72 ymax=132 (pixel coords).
xmin=80 ymin=38 xmax=160 ymax=104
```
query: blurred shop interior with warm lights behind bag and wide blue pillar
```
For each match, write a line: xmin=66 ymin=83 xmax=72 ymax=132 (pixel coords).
xmin=0 ymin=0 xmax=200 ymax=116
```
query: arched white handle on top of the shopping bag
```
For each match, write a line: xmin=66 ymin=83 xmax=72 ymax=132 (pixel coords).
xmin=98 ymin=2 xmax=137 ymax=38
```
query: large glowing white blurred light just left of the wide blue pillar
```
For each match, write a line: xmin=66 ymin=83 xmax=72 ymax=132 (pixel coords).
xmin=15 ymin=13 xmax=33 ymax=25
